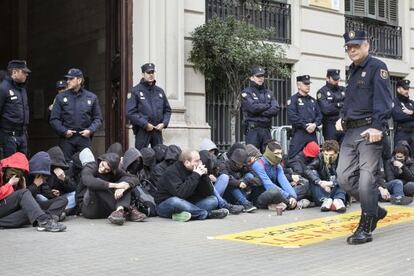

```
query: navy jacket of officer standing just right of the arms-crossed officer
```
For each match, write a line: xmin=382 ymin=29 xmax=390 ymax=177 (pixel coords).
xmin=287 ymin=92 xmax=322 ymax=129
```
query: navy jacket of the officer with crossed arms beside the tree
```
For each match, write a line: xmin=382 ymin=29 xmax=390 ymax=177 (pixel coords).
xmin=241 ymin=81 xmax=280 ymax=128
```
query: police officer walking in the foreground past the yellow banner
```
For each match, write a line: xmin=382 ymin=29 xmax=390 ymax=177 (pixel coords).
xmin=336 ymin=31 xmax=392 ymax=244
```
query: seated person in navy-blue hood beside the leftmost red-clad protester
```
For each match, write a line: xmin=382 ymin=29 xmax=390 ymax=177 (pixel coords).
xmin=27 ymin=151 xmax=68 ymax=221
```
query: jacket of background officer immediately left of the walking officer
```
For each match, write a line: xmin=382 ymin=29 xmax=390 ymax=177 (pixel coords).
xmin=316 ymin=83 xmax=345 ymax=122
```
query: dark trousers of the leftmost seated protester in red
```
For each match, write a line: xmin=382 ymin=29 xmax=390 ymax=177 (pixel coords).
xmin=0 ymin=189 xmax=45 ymax=228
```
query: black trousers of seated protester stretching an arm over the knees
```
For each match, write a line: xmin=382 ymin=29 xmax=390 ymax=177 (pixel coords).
xmin=82 ymin=189 xmax=131 ymax=219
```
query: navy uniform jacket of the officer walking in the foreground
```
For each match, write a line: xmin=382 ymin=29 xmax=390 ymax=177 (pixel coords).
xmin=342 ymin=56 xmax=392 ymax=130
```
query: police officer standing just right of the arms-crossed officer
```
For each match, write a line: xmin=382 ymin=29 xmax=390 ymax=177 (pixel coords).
xmin=287 ymin=75 xmax=322 ymax=159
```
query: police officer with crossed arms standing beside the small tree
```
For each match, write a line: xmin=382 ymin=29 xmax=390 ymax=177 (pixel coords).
xmin=241 ymin=67 xmax=280 ymax=152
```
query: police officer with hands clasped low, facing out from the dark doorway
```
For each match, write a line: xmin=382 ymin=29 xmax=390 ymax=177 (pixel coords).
xmin=50 ymin=68 xmax=102 ymax=160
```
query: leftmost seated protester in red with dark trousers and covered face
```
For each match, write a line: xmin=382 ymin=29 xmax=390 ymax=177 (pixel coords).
xmin=0 ymin=152 xmax=66 ymax=232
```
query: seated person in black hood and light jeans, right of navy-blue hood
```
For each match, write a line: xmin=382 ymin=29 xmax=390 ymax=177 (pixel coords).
xmin=47 ymin=146 xmax=77 ymax=215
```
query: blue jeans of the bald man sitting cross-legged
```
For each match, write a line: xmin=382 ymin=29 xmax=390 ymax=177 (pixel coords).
xmin=157 ymin=196 xmax=218 ymax=220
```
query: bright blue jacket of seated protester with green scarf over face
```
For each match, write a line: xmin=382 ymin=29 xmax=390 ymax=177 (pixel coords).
xmin=252 ymin=157 xmax=297 ymax=199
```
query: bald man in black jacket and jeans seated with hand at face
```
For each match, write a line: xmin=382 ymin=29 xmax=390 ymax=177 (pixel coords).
xmin=155 ymin=151 xmax=229 ymax=221
